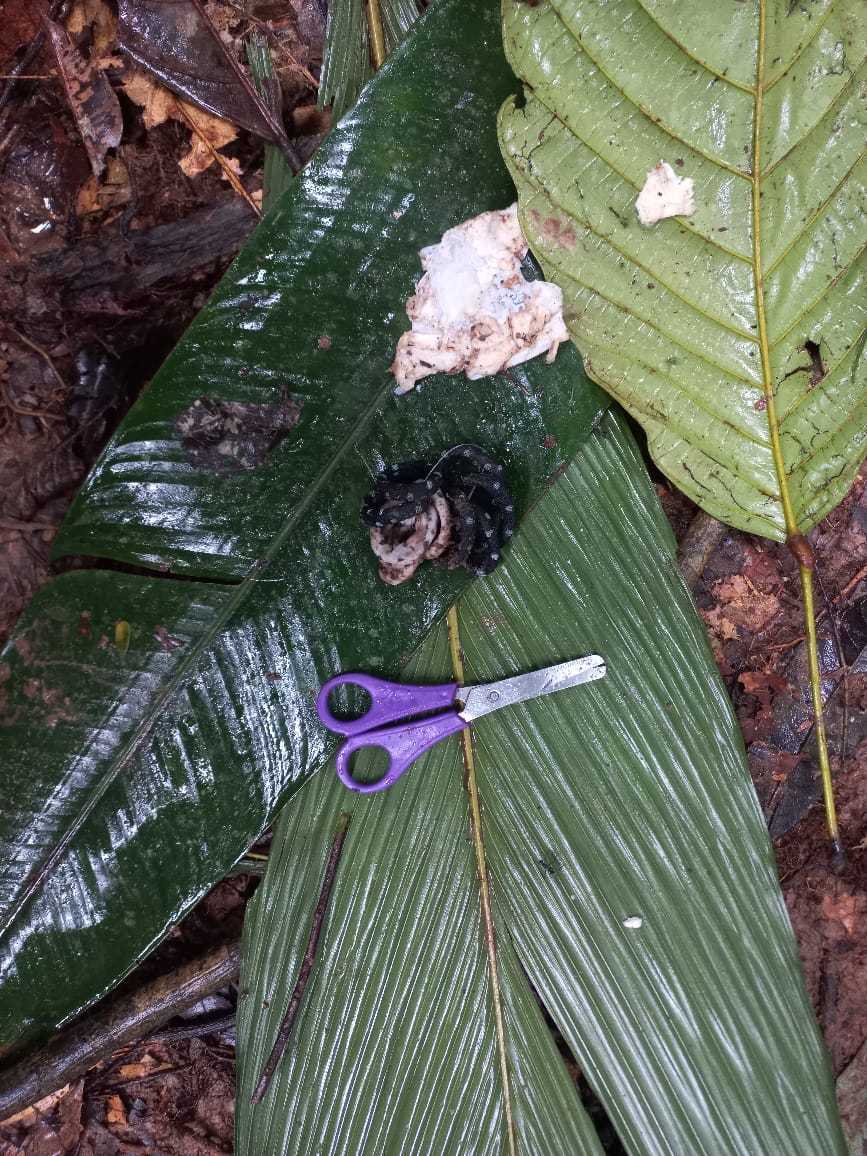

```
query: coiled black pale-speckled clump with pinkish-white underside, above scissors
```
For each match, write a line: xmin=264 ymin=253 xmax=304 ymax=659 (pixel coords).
xmin=361 ymin=445 xmax=514 ymax=586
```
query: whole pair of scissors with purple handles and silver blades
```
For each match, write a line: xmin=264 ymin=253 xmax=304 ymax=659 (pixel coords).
xmin=316 ymin=654 xmax=606 ymax=794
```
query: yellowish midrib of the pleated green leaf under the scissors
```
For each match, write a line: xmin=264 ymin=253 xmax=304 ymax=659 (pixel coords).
xmin=446 ymin=606 xmax=518 ymax=1156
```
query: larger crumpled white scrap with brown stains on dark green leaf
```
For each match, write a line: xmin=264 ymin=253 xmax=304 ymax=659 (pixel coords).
xmin=391 ymin=205 xmax=569 ymax=393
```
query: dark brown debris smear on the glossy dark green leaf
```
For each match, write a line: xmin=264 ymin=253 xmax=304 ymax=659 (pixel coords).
xmin=172 ymin=395 xmax=304 ymax=477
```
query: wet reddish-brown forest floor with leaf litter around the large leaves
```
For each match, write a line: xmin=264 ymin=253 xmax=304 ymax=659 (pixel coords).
xmin=0 ymin=0 xmax=867 ymax=1156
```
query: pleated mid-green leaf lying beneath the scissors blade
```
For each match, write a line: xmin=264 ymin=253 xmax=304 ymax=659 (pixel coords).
xmin=238 ymin=418 xmax=843 ymax=1156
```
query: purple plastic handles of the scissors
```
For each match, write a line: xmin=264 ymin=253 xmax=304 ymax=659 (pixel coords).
xmin=316 ymin=674 xmax=469 ymax=794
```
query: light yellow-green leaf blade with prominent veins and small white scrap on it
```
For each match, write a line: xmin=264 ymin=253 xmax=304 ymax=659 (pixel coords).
xmin=501 ymin=0 xmax=867 ymax=539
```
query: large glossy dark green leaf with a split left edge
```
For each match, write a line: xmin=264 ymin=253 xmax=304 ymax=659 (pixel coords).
xmin=0 ymin=0 xmax=601 ymax=1046
